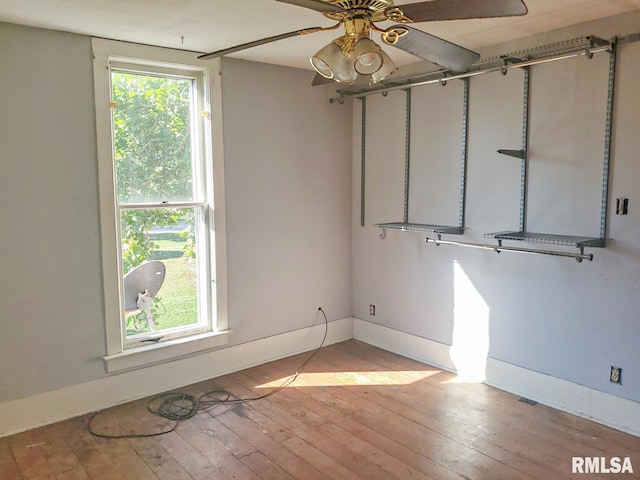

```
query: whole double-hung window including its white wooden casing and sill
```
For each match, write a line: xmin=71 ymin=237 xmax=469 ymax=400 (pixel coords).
xmin=93 ymin=39 xmax=227 ymax=371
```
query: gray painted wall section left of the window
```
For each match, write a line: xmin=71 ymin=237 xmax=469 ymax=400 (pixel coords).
xmin=0 ymin=25 xmax=105 ymax=401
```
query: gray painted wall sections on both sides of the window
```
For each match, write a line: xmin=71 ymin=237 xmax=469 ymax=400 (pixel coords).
xmin=0 ymin=24 xmax=351 ymax=403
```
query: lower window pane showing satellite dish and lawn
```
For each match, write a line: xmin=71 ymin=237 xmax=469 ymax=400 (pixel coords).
xmin=120 ymin=207 xmax=201 ymax=338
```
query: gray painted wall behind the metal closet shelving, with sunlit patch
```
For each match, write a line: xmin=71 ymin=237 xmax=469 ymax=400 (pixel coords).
xmin=352 ymin=13 xmax=640 ymax=401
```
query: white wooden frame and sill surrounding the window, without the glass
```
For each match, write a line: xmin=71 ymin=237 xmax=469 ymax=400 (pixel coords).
xmin=92 ymin=38 xmax=229 ymax=372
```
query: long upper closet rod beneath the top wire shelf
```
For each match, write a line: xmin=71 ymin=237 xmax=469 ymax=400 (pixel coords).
xmin=329 ymin=44 xmax=612 ymax=103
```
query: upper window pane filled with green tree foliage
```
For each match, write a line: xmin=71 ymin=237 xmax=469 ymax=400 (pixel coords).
xmin=111 ymin=70 xmax=194 ymax=204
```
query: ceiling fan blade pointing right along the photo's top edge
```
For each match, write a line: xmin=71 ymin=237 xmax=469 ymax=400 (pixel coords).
xmin=396 ymin=0 xmax=528 ymax=22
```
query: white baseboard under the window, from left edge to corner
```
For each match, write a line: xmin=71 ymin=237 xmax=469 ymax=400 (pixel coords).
xmin=0 ymin=317 xmax=353 ymax=438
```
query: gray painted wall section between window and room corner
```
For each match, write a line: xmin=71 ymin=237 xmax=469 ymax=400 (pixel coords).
xmin=222 ymin=59 xmax=351 ymax=342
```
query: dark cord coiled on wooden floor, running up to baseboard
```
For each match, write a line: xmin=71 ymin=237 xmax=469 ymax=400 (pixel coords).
xmin=88 ymin=307 xmax=329 ymax=438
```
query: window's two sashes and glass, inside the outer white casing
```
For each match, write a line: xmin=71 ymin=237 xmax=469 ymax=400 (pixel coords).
xmin=110 ymin=62 xmax=211 ymax=347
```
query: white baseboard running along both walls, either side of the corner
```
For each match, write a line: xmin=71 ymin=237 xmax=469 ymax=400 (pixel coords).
xmin=0 ymin=318 xmax=640 ymax=438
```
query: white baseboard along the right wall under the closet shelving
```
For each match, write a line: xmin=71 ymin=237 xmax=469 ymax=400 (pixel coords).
xmin=353 ymin=318 xmax=640 ymax=436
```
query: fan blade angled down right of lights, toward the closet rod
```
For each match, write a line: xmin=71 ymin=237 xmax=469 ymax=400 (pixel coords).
xmin=383 ymin=25 xmax=480 ymax=72
